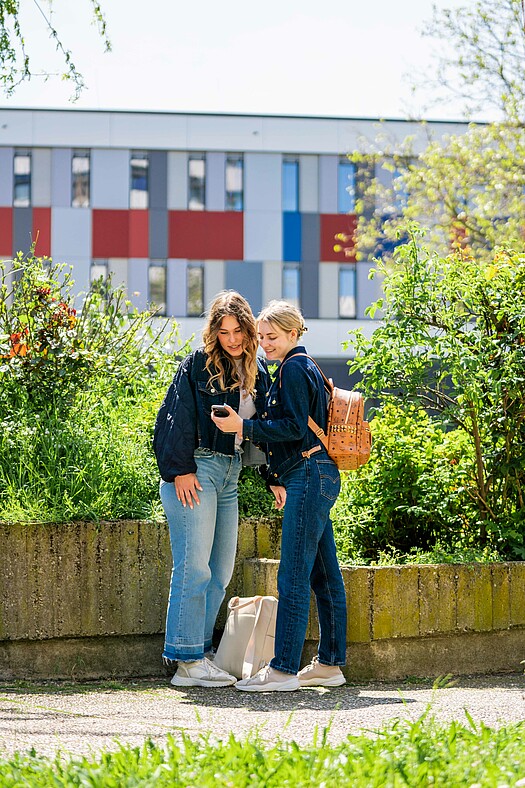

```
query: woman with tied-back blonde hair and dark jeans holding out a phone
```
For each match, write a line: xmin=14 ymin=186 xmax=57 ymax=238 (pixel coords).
xmin=214 ymin=301 xmax=346 ymax=692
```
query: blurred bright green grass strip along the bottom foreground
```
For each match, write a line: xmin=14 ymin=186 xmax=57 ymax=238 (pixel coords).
xmin=0 ymin=716 xmax=525 ymax=788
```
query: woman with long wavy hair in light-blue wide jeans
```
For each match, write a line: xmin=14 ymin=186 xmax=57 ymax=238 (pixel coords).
xmin=153 ymin=290 xmax=268 ymax=687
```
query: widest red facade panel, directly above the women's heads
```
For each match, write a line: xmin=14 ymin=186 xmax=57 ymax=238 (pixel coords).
xmin=168 ymin=211 xmax=244 ymax=260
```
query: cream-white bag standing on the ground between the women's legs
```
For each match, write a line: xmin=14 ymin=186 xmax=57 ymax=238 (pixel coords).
xmin=213 ymin=596 xmax=277 ymax=679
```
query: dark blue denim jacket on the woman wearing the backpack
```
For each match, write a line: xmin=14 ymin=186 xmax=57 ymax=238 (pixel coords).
xmin=243 ymin=346 xmax=328 ymax=484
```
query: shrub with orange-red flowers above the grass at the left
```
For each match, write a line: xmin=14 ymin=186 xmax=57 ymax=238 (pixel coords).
xmin=0 ymin=253 xmax=183 ymax=407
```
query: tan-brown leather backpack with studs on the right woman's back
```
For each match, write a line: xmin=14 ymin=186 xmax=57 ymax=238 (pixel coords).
xmin=279 ymin=353 xmax=372 ymax=471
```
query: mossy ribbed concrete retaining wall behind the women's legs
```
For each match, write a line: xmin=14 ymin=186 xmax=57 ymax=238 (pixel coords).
xmin=0 ymin=521 xmax=525 ymax=679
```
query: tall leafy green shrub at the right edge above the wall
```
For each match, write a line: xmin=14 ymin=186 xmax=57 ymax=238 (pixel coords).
xmin=350 ymin=227 xmax=525 ymax=557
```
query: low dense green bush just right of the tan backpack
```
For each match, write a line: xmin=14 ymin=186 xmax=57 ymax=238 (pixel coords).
xmin=333 ymin=403 xmax=475 ymax=563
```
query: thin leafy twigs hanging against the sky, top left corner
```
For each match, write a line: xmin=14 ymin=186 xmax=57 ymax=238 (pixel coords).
xmin=0 ymin=0 xmax=111 ymax=99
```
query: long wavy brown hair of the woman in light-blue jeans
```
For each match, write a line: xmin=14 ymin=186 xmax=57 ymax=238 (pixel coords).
xmin=202 ymin=290 xmax=258 ymax=394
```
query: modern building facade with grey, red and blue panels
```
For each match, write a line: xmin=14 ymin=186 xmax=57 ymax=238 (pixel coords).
xmin=0 ymin=109 xmax=465 ymax=384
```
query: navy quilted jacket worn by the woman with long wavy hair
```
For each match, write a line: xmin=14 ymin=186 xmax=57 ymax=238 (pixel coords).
xmin=153 ymin=350 xmax=270 ymax=482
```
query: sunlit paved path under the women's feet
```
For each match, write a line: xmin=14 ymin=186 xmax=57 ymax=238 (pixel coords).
xmin=0 ymin=674 xmax=525 ymax=755
